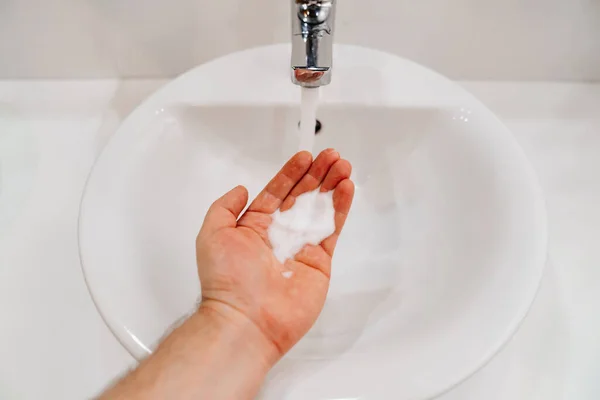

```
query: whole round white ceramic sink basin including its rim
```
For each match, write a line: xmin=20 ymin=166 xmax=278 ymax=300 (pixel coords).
xmin=79 ymin=45 xmax=546 ymax=400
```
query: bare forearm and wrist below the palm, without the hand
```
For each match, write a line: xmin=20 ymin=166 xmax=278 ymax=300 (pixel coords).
xmin=101 ymin=306 xmax=279 ymax=400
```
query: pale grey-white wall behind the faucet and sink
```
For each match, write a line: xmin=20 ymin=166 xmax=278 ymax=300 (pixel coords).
xmin=0 ymin=0 xmax=600 ymax=80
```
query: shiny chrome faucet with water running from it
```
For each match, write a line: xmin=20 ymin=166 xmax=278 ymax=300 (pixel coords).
xmin=292 ymin=0 xmax=337 ymax=88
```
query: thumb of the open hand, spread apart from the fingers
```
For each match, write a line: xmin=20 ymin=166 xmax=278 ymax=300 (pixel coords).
xmin=200 ymin=186 xmax=248 ymax=233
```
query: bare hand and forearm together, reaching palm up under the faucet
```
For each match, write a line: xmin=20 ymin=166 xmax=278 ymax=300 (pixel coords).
xmin=101 ymin=149 xmax=354 ymax=400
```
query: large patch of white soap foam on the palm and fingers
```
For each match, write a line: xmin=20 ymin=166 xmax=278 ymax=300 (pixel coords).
xmin=268 ymin=188 xmax=335 ymax=263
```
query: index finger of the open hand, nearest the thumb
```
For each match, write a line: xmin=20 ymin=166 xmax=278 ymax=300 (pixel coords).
xmin=248 ymin=151 xmax=312 ymax=214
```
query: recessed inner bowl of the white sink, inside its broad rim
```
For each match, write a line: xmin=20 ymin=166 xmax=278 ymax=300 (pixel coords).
xmin=129 ymin=105 xmax=517 ymax=350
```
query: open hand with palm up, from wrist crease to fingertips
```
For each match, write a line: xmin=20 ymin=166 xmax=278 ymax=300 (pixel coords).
xmin=196 ymin=149 xmax=354 ymax=362
